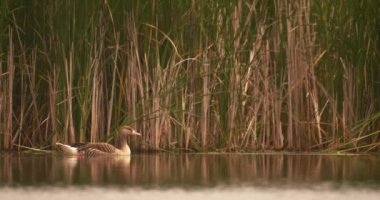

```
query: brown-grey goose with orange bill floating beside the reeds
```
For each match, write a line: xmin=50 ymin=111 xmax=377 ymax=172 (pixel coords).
xmin=56 ymin=125 xmax=141 ymax=157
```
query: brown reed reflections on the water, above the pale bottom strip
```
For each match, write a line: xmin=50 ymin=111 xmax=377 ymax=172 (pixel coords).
xmin=0 ymin=154 xmax=380 ymax=188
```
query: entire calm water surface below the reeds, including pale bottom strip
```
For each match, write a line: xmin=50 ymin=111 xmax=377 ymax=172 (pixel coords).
xmin=0 ymin=154 xmax=380 ymax=200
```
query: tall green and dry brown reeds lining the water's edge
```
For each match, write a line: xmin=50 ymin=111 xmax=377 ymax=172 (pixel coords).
xmin=0 ymin=0 xmax=380 ymax=153
